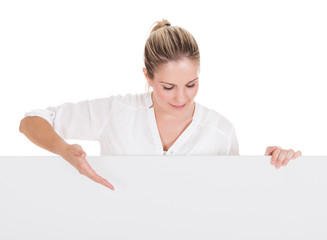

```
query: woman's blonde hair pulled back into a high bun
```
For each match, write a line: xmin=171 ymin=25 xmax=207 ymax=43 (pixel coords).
xmin=144 ymin=19 xmax=200 ymax=93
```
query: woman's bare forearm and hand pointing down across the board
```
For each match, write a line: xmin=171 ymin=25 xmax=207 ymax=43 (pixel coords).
xmin=19 ymin=117 xmax=114 ymax=190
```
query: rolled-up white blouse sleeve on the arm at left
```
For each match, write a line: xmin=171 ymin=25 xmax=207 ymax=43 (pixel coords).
xmin=25 ymin=97 xmax=113 ymax=140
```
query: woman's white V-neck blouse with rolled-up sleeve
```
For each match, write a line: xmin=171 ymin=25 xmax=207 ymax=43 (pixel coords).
xmin=25 ymin=92 xmax=239 ymax=155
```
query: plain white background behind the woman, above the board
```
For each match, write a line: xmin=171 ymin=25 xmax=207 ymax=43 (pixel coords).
xmin=0 ymin=0 xmax=327 ymax=155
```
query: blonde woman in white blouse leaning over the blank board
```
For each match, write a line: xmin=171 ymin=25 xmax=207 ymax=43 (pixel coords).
xmin=20 ymin=20 xmax=301 ymax=190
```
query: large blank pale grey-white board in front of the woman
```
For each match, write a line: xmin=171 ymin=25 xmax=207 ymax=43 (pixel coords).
xmin=0 ymin=156 xmax=327 ymax=240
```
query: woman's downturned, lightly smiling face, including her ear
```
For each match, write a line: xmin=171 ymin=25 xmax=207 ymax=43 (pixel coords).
xmin=143 ymin=58 xmax=199 ymax=118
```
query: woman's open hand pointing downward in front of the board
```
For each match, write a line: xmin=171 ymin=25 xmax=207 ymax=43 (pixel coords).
xmin=61 ymin=144 xmax=114 ymax=190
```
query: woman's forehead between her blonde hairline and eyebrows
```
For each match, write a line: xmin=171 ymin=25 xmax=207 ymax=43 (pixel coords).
xmin=154 ymin=58 xmax=199 ymax=84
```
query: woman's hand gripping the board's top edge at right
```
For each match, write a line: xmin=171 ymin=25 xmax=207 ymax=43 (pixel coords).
xmin=265 ymin=146 xmax=302 ymax=168
